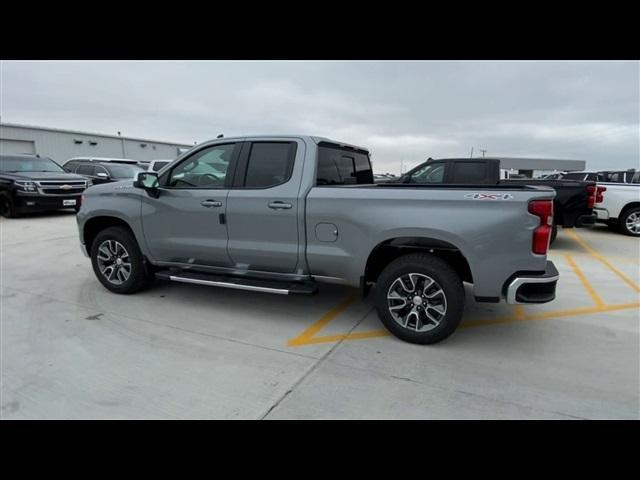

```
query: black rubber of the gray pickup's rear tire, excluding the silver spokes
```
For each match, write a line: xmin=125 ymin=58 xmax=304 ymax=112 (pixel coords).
xmin=375 ymin=253 xmax=464 ymax=345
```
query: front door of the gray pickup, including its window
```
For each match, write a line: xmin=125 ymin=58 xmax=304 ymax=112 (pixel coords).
xmin=142 ymin=143 xmax=240 ymax=267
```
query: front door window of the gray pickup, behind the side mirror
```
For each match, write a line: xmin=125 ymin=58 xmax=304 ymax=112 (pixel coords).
xmin=169 ymin=143 xmax=236 ymax=188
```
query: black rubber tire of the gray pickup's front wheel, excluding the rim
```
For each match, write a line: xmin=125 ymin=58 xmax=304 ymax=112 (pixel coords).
xmin=91 ymin=227 xmax=153 ymax=294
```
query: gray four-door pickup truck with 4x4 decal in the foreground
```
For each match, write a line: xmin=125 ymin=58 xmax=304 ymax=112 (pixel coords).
xmin=77 ymin=135 xmax=558 ymax=344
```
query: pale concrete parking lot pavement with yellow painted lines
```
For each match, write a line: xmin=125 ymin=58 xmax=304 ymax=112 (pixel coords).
xmin=0 ymin=212 xmax=640 ymax=419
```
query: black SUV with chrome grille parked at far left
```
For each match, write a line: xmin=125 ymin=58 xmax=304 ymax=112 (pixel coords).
xmin=0 ymin=155 xmax=91 ymax=218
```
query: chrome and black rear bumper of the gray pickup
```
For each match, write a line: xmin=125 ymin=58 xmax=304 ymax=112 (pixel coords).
xmin=505 ymin=260 xmax=560 ymax=304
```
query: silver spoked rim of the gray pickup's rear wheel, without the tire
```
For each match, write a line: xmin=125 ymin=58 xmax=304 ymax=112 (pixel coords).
xmin=387 ymin=273 xmax=447 ymax=332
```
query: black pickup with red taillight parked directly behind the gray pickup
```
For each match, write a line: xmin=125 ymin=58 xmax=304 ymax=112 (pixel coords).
xmin=400 ymin=158 xmax=605 ymax=243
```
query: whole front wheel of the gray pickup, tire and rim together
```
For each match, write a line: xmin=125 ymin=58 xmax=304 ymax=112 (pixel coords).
xmin=91 ymin=227 xmax=152 ymax=294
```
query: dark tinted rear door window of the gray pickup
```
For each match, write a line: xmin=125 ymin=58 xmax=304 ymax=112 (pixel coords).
xmin=244 ymin=142 xmax=296 ymax=188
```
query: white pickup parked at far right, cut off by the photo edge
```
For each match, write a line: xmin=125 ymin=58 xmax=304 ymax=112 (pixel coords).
xmin=594 ymin=171 xmax=640 ymax=237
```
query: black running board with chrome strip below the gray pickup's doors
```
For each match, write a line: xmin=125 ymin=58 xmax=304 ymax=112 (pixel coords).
xmin=156 ymin=270 xmax=318 ymax=295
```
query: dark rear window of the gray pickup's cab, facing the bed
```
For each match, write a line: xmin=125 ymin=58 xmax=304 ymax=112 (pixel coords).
xmin=316 ymin=147 xmax=373 ymax=185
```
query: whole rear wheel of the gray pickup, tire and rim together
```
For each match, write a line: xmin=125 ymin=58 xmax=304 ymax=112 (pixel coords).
xmin=376 ymin=254 xmax=464 ymax=345
